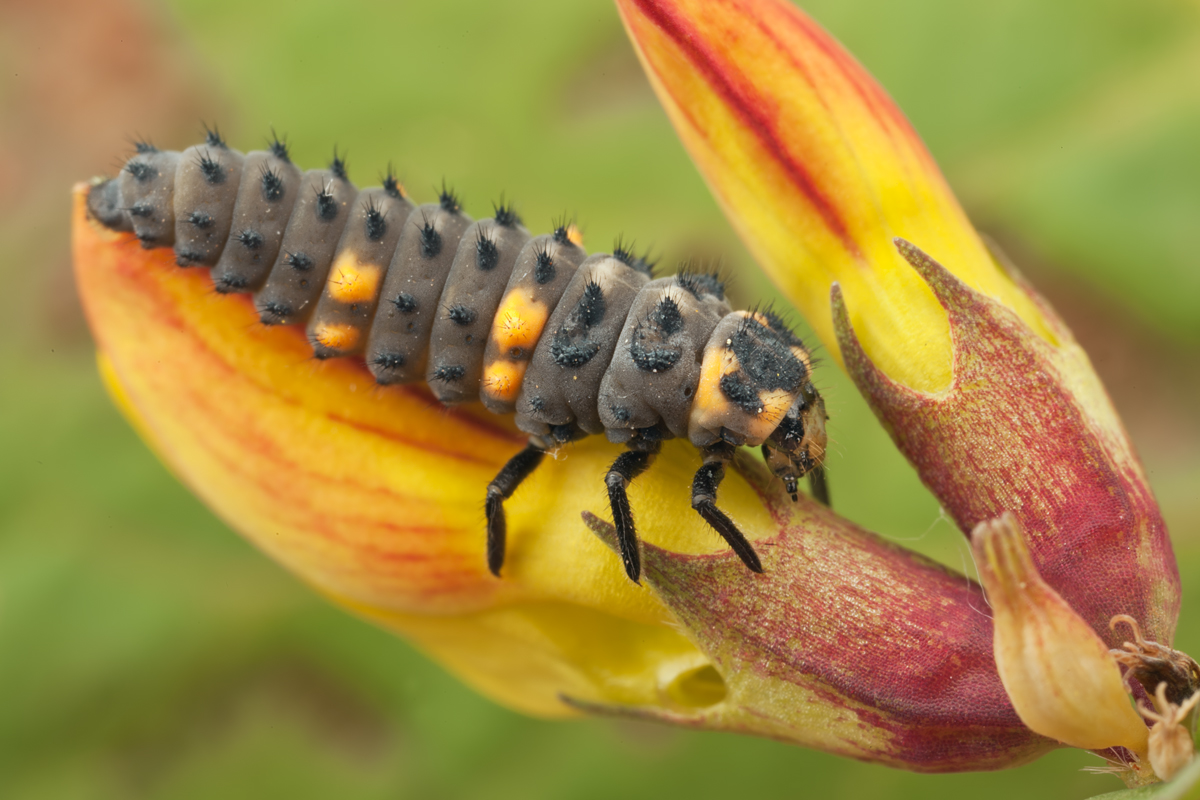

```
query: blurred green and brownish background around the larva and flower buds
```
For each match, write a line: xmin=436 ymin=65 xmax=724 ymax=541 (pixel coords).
xmin=0 ymin=0 xmax=1200 ymax=800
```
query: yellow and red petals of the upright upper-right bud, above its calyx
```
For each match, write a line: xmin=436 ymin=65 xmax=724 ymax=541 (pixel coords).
xmin=617 ymin=0 xmax=1049 ymax=391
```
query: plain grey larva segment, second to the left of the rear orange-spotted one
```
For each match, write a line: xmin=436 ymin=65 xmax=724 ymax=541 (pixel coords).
xmin=212 ymin=150 xmax=300 ymax=289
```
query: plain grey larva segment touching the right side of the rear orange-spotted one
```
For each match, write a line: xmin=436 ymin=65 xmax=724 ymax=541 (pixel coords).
xmin=366 ymin=198 xmax=473 ymax=384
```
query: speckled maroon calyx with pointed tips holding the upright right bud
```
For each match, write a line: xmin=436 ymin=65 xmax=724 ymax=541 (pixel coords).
xmin=833 ymin=241 xmax=1180 ymax=645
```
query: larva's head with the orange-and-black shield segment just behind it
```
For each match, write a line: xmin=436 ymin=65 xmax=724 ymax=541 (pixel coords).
xmin=688 ymin=311 xmax=826 ymax=488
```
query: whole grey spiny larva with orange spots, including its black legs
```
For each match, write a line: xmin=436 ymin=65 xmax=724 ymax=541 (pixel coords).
xmin=88 ymin=130 xmax=828 ymax=582
